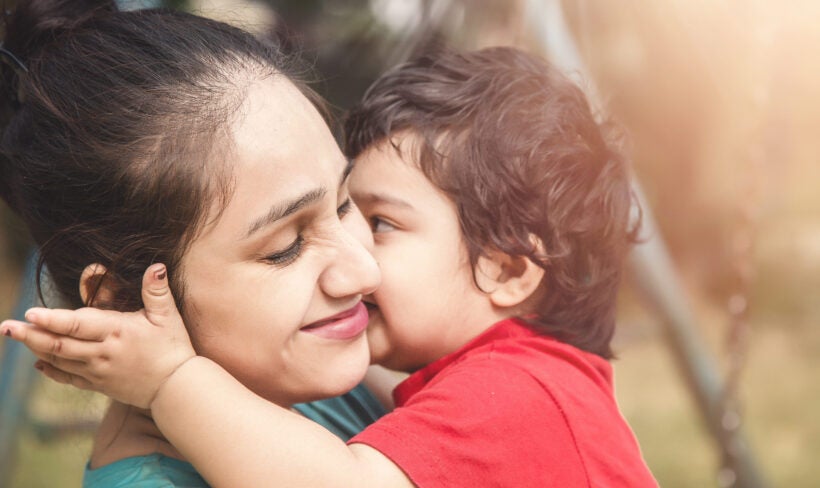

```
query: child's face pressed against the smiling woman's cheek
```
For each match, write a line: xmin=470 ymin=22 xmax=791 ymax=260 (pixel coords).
xmin=350 ymin=135 xmax=499 ymax=371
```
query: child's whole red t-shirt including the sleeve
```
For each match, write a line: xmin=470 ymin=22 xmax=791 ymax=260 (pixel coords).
xmin=350 ymin=319 xmax=657 ymax=488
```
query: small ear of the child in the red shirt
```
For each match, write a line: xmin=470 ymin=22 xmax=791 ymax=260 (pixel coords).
xmin=476 ymin=246 xmax=544 ymax=308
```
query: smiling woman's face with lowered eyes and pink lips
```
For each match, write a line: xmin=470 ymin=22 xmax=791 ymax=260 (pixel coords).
xmin=181 ymin=77 xmax=380 ymax=405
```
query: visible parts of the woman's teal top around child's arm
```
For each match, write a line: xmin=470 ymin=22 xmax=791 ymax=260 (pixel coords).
xmin=83 ymin=385 xmax=386 ymax=488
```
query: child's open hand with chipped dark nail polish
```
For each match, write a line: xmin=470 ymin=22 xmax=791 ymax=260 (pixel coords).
xmin=0 ymin=264 xmax=196 ymax=408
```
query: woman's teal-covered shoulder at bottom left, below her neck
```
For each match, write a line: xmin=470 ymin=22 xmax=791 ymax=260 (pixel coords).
xmin=83 ymin=453 xmax=208 ymax=488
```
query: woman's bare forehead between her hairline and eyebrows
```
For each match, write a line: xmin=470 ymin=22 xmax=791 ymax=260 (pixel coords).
xmin=191 ymin=78 xmax=347 ymax=237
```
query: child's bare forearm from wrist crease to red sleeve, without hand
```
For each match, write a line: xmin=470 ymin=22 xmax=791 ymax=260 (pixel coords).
xmin=151 ymin=357 xmax=412 ymax=487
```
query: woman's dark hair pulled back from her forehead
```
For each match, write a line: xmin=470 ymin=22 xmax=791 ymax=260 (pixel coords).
xmin=0 ymin=0 xmax=310 ymax=310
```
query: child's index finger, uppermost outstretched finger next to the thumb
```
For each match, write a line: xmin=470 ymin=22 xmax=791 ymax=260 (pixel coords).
xmin=26 ymin=308 xmax=118 ymax=341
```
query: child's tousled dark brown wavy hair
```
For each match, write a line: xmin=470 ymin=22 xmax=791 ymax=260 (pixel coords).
xmin=345 ymin=48 xmax=637 ymax=359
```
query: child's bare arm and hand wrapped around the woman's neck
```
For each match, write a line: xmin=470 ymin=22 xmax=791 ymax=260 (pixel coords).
xmin=0 ymin=268 xmax=412 ymax=487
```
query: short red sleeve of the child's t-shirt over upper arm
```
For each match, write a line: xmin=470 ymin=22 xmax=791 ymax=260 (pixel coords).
xmin=350 ymin=358 xmax=589 ymax=487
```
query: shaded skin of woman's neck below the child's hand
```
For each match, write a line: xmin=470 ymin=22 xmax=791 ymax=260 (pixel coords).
xmin=91 ymin=402 xmax=185 ymax=469
